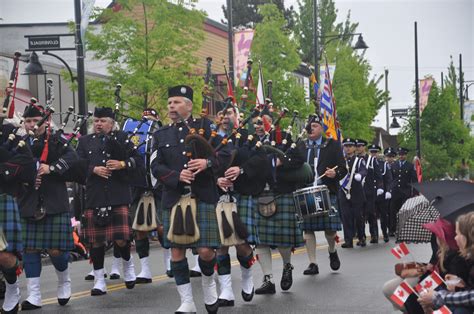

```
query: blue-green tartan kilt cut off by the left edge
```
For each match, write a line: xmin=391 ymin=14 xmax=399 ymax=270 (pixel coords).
xmin=0 ymin=194 xmax=23 ymax=253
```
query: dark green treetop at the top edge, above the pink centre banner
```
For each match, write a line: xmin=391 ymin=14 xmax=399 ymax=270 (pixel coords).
xmin=222 ymin=0 xmax=296 ymax=29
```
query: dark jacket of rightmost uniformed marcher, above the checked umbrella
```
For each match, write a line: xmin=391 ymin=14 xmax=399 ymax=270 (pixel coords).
xmin=392 ymin=160 xmax=417 ymax=199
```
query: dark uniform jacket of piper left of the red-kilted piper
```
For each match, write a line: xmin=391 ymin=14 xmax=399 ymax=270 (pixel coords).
xmin=18 ymin=134 xmax=77 ymax=217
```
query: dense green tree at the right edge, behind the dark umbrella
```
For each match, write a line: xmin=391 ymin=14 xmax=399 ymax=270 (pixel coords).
xmin=400 ymin=62 xmax=474 ymax=179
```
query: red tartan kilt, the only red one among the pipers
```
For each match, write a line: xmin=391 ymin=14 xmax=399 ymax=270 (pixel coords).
xmin=82 ymin=205 xmax=132 ymax=244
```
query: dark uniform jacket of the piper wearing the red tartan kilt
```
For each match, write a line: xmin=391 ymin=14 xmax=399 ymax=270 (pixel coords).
xmin=77 ymin=131 xmax=144 ymax=209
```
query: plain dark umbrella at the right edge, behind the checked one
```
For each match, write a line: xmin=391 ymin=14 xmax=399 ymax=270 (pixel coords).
xmin=413 ymin=181 xmax=474 ymax=222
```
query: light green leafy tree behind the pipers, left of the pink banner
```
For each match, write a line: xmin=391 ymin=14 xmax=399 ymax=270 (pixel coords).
xmin=87 ymin=0 xmax=204 ymax=116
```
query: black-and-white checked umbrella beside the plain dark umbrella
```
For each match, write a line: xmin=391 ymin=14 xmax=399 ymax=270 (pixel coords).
xmin=397 ymin=196 xmax=439 ymax=243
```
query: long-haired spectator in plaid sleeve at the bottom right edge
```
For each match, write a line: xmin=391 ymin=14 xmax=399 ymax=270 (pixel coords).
xmin=418 ymin=212 xmax=474 ymax=314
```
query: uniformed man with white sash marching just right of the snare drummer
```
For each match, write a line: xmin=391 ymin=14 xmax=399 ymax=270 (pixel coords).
xmin=339 ymin=138 xmax=367 ymax=248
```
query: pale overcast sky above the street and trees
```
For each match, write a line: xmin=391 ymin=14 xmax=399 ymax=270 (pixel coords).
xmin=0 ymin=0 xmax=474 ymax=131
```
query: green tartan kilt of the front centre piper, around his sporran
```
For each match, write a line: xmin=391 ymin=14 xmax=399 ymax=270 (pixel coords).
xmin=162 ymin=201 xmax=221 ymax=249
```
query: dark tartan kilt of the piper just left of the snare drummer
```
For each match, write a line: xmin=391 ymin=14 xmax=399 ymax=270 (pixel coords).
xmin=256 ymin=193 xmax=304 ymax=247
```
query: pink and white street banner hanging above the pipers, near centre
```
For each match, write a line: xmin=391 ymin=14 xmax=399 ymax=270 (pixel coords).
xmin=234 ymin=29 xmax=254 ymax=86
